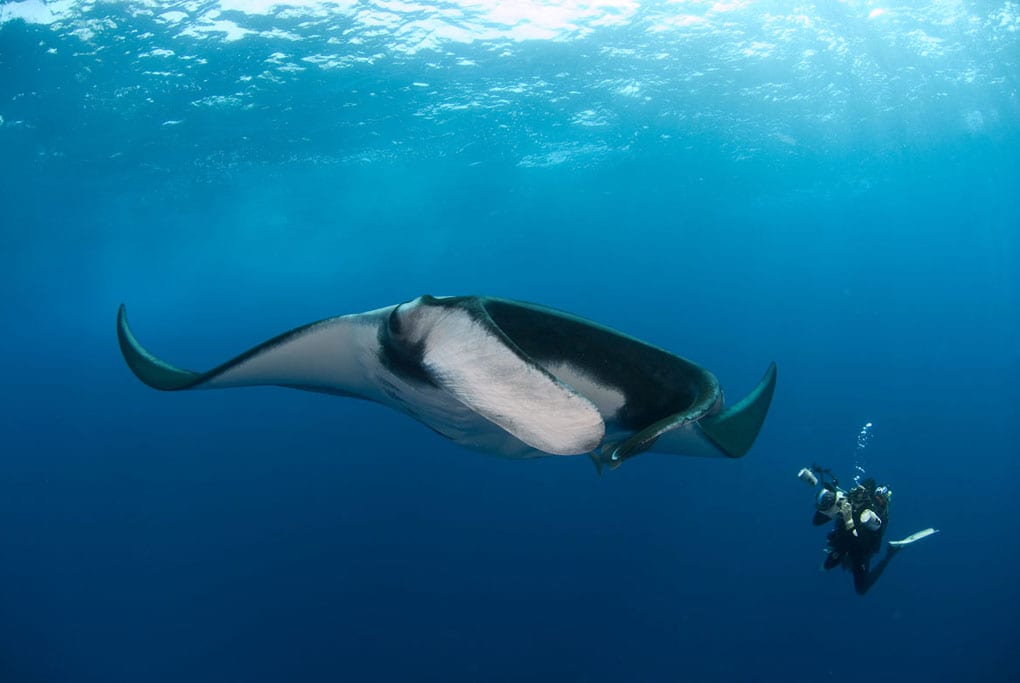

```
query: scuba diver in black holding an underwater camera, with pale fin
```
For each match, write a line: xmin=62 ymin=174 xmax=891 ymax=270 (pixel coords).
xmin=797 ymin=465 xmax=935 ymax=595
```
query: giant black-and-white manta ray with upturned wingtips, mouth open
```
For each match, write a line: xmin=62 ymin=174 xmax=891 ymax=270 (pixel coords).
xmin=117 ymin=296 xmax=775 ymax=472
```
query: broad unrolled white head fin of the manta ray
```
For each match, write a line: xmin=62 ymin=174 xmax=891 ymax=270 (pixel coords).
xmin=422 ymin=304 xmax=606 ymax=456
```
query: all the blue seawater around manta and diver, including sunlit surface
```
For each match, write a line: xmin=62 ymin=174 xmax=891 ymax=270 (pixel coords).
xmin=0 ymin=0 xmax=1020 ymax=683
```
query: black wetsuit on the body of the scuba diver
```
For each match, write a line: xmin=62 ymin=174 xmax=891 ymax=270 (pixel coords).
xmin=813 ymin=479 xmax=896 ymax=595
